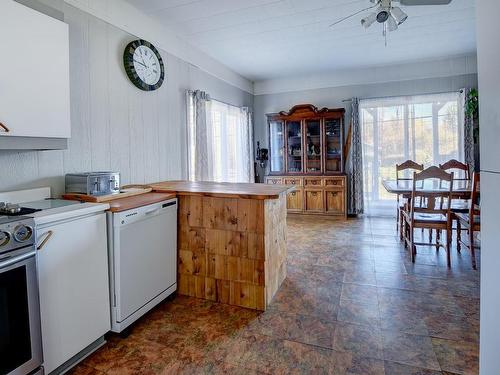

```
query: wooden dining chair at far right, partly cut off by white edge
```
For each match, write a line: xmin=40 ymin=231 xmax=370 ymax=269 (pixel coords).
xmin=454 ymin=172 xmax=481 ymax=269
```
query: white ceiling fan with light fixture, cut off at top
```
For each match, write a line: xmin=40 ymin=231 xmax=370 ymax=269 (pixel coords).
xmin=330 ymin=0 xmax=452 ymax=36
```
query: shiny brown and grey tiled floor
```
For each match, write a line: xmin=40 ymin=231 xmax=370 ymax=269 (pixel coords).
xmin=72 ymin=217 xmax=479 ymax=375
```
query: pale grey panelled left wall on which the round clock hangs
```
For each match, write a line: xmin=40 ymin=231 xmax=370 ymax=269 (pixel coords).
xmin=0 ymin=0 xmax=253 ymax=195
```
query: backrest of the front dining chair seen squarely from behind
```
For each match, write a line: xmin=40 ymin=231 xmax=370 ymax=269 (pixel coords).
xmin=411 ymin=166 xmax=453 ymax=220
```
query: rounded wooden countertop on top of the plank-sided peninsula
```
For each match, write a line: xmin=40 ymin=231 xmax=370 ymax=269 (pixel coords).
xmin=147 ymin=181 xmax=295 ymax=199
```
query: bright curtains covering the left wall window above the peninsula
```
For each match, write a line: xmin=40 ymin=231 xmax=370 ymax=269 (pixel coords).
xmin=187 ymin=91 xmax=254 ymax=182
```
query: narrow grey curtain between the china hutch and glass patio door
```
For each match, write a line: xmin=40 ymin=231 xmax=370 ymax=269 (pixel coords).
xmin=347 ymin=98 xmax=364 ymax=215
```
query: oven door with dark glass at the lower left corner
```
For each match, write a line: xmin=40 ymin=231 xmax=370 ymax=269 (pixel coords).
xmin=0 ymin=248 xmax=42 ymax=375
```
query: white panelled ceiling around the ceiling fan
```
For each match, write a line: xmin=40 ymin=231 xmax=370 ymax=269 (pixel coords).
xmin=123 ymin=0 xmax=476 ymax=81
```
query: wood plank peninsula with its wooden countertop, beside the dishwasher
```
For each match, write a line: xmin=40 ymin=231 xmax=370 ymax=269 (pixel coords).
xmin=148 ymin=181 xmax=293 ymax=310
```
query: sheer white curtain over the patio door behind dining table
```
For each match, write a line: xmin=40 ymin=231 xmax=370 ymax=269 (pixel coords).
xmin=360 ymin=92 xmax=464 ymax=216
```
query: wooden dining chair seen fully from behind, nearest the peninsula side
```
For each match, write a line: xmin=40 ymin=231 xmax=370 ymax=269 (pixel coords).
xmin=401 ymin=166 xmax=453 ymax=267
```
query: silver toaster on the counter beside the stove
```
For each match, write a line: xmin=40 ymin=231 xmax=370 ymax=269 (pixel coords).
xmin=66 ymin=172 xmax=120 ymax=196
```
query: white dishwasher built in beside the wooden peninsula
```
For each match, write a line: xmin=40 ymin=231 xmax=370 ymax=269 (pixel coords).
xmin=107 ymin=199 xmax=177 ymax=333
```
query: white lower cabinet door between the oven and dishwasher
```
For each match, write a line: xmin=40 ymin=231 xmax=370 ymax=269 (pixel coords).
xmin=37 ymin=213 xmax=110 ymax=373
